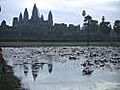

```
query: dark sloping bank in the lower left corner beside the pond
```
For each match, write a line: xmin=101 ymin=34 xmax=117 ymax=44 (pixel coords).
xmin=0 ymin=65 xmax=25 ymax=90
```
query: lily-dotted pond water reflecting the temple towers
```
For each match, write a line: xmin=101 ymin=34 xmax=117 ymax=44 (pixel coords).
xmin=4 ymin=47 xmax=120 ymax=90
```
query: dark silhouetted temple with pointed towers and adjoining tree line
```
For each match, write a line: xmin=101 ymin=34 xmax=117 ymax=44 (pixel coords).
xmin=0 ymin=4 xmax=120 ymax=41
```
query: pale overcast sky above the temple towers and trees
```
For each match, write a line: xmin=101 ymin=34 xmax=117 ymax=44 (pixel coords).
xmin=0 ymin=0 xmax=120 ymax=24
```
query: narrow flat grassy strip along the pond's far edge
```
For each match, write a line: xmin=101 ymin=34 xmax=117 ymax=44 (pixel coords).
xmin=0 ymin=42 xmax=120 ymax=47
